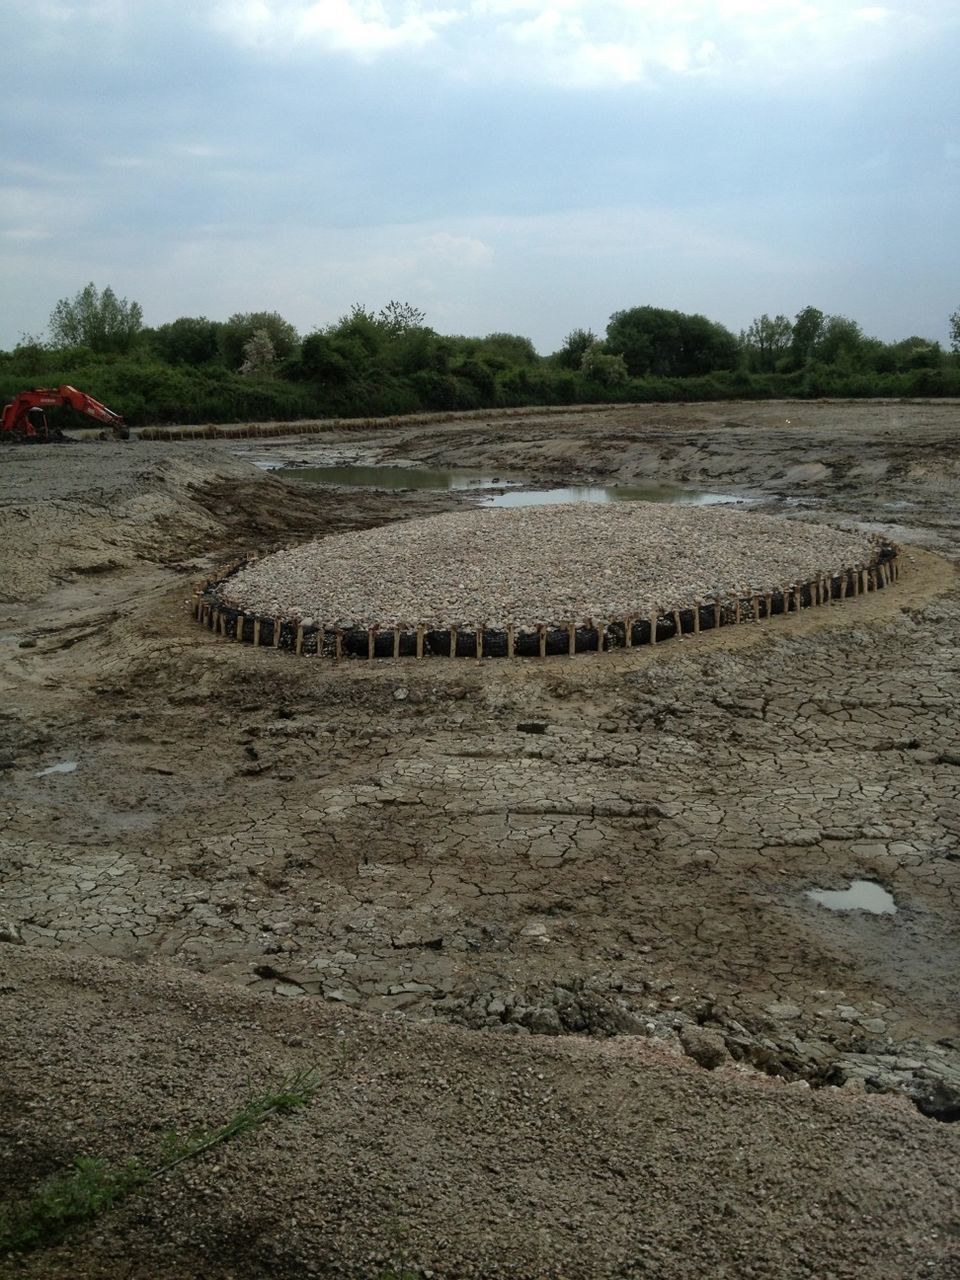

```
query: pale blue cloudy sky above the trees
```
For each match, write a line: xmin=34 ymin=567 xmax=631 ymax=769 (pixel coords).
xmin=0 ymin=0 xmax=960 ymax=353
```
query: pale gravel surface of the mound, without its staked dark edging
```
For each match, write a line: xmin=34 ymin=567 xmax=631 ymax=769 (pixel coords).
xmin=223 ymin=502 xmax=877 ymax=628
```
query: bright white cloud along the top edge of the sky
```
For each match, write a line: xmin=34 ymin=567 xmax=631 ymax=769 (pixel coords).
xmin=214 ymin=0 xmax=957 ymax=88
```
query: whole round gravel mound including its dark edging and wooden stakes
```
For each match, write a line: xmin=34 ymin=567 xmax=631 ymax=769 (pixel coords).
xmin=195 ymin=502 xmax=897 ymax=657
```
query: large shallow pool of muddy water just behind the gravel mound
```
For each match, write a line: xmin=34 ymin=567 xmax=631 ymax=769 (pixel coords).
xmin=271 ymin=465 xmax=741 ymax=507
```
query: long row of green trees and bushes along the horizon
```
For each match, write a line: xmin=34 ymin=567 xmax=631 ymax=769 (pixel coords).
xmin=0 ymin=284 xmax=960 ymax=425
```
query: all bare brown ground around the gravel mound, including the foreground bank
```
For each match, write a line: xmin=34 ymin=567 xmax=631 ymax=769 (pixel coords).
xmin=0 ymin=403 xmax=960 ymax=1280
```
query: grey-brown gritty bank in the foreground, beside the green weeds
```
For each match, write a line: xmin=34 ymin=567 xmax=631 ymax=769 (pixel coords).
xmin=0 ymin=947 xmax=960 ymax=1280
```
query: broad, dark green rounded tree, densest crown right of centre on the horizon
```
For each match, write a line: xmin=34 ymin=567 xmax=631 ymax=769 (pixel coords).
xmin=605 ymin=307 xmax=739 ymax=378
